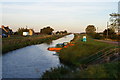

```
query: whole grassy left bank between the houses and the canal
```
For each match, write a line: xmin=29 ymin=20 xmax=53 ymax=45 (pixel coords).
xmin=2 ymin=34 xmax=67 ymax=54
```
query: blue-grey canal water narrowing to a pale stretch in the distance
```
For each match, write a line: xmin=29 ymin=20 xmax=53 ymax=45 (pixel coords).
xmin=2 ymin=34 xmax=74 ymax=78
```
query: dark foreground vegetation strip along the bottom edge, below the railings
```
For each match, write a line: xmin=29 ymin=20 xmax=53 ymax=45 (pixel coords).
xmin=42 ymin=62 xmax=120 ymax=80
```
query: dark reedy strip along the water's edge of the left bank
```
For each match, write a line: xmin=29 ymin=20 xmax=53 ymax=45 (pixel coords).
xmin=2 ymin=33 xmax=71 ymax=55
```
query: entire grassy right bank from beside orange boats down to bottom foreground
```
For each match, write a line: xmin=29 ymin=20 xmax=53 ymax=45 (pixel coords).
xmin=42 ymin=34 xmax=120 ymax=80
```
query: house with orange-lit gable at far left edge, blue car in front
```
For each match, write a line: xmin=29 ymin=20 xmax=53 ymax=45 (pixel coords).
xmin=0 ymin=25 xmax=13 ymax=37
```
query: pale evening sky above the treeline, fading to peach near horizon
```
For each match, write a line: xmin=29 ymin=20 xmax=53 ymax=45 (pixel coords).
xmin=0 ymin=0 xmax=119 ymax=32
